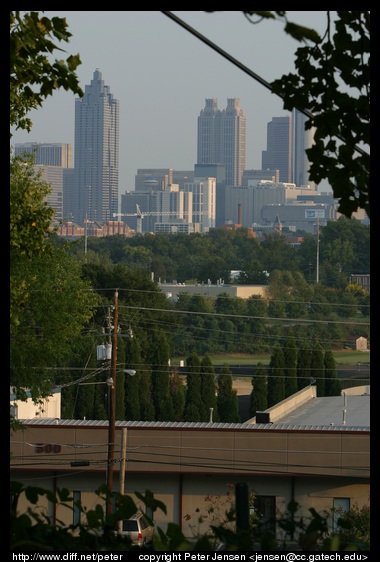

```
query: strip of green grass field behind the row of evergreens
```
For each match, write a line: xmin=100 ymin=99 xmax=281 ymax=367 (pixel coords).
xmin=171 ymin=349 xmax=370 ymax=365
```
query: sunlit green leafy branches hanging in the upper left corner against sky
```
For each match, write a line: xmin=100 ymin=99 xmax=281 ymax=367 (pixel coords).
xmin=10 ymin=11 xmax=83 ymax=136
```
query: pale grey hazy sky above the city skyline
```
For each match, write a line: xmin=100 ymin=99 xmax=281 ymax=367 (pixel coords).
xmin=12 ymin=11 xmax=327 ymax=193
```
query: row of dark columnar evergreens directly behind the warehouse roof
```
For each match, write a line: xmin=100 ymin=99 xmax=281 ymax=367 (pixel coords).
xmin=62 ymin=332 xmax=342 ymax=423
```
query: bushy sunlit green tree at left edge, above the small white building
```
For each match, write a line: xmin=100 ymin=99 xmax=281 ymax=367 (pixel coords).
xmin=10 ymin=241 xmax=99 ymax=399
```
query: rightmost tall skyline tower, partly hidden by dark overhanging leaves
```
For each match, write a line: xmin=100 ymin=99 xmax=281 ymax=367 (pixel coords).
xmin=292 ymin=109 xmax=315 ymax=189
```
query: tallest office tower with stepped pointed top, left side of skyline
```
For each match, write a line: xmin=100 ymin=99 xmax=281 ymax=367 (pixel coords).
xmin=73 ymin=69 xmax=119 ymax=226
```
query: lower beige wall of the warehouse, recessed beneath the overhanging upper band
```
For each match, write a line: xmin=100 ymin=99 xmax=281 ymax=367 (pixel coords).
xmin=16 ymin=471 xmax=370 ymax=539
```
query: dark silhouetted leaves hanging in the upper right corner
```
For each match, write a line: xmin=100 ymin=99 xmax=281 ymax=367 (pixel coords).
xmin=245 ymin=11 xmax=370 ymax=218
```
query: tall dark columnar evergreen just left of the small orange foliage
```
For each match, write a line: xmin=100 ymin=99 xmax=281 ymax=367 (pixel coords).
xmin=149 ymin=332 xmax=174 ymax=421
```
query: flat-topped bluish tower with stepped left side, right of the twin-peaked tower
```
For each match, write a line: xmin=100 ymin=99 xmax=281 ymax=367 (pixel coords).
xmin=261 ymin=117 xmax=293 ymax=182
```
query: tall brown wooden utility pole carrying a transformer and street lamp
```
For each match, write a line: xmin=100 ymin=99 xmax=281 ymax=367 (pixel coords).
xmin=106 ymin=290 xmax=119 ymax=515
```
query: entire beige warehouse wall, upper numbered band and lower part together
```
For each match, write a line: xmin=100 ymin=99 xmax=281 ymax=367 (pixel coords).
xmin=11 ymin=420 xmax=370 ymax=538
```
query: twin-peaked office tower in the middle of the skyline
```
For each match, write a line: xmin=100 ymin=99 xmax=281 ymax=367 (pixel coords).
xmin=197 ymin=98 xmax=247 ymax=185
